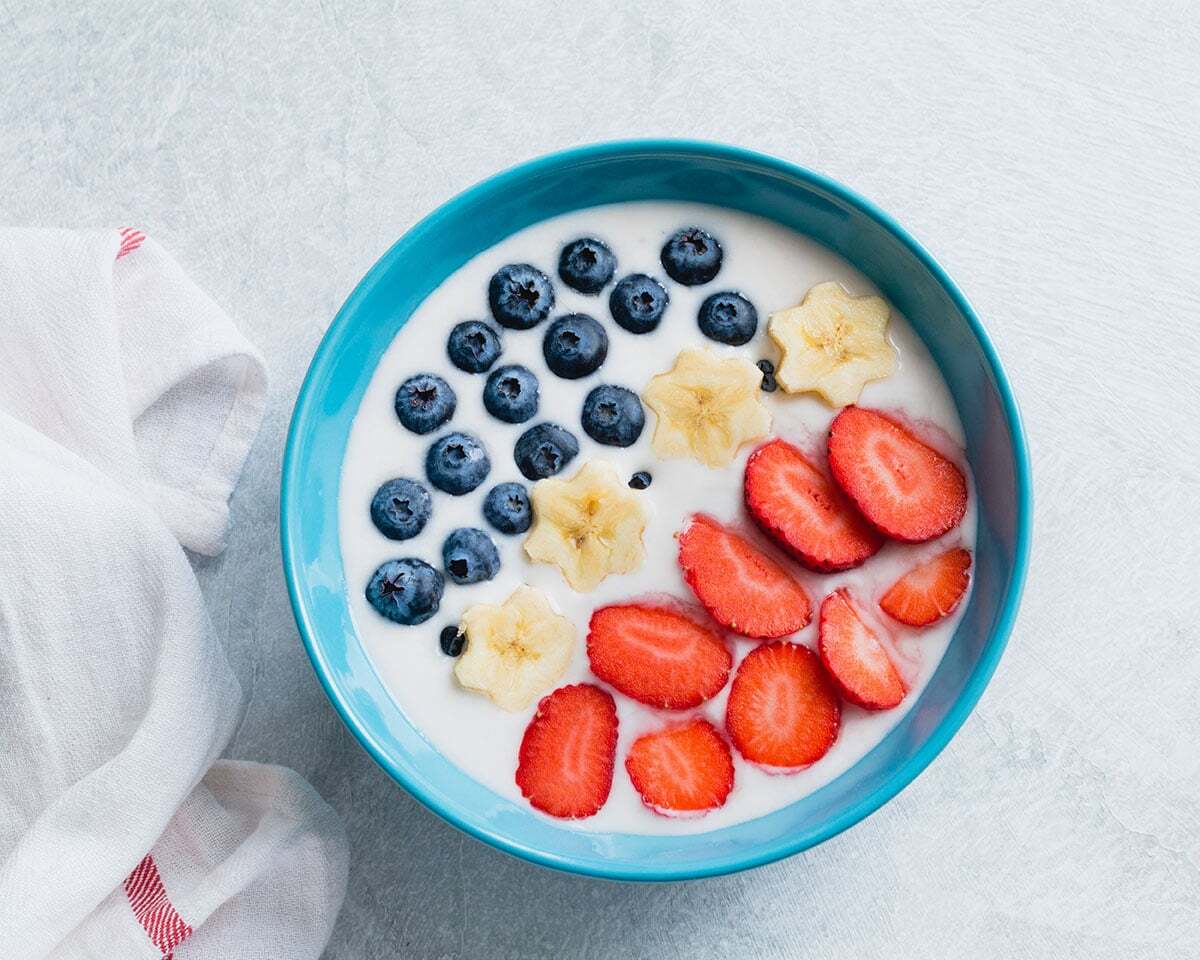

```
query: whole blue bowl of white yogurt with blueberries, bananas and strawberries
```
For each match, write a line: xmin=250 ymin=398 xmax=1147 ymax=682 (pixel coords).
xmin=282 ymin=142 xmax=1028 ymax=880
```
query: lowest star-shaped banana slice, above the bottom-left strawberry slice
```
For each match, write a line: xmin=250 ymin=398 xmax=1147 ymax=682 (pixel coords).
xmin=454 ymin=587 xmax=575 ymax=713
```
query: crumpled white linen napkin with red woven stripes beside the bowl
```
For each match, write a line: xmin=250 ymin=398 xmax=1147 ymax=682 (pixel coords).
xmin=0 ymin=229 xmax=347 ymax=960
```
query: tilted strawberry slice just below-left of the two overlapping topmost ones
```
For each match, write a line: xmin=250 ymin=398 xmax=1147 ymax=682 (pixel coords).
xmin=679 ymin=514 xmax=812 ymax=640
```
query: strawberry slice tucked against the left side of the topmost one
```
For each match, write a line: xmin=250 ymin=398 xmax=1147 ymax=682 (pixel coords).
xmin=744 ymin=439 xmax=883 ymax=574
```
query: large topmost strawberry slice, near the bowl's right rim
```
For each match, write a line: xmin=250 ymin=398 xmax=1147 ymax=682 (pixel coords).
xmin=829 ymin=407 xmax=967 ymax=544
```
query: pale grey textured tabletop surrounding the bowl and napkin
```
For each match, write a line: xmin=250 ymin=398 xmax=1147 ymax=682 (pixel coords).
xmin=0 ymin=0 xmax=1200 ymax=960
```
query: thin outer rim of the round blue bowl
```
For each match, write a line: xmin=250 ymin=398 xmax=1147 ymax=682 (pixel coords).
xmin=280 ymin=138 xmax=1033 ymax=881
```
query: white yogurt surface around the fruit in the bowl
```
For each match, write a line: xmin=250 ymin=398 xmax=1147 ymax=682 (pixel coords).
xmin=340 ymin=202 xmax=976 ymax=834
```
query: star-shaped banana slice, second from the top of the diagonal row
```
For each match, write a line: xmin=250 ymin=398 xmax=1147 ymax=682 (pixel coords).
xmin=642 ymin=348 xmax=770 ymax=467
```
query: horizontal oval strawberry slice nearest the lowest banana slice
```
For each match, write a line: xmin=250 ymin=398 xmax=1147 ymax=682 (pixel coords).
xmin=588 ymin=604 xmax=733 ymax=710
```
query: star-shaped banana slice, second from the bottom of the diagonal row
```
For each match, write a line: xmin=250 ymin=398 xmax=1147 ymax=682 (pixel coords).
xmin=524 ymin=460 xmax=646 ymax=593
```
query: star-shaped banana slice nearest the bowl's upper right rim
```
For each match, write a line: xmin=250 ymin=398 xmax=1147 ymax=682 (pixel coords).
xmin=767 ymin=282 xmax=896 ymax=407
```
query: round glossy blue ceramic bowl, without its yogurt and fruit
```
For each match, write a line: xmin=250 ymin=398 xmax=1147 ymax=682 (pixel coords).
xmin=281 ymin=140 xmax=1031 ymax=880
